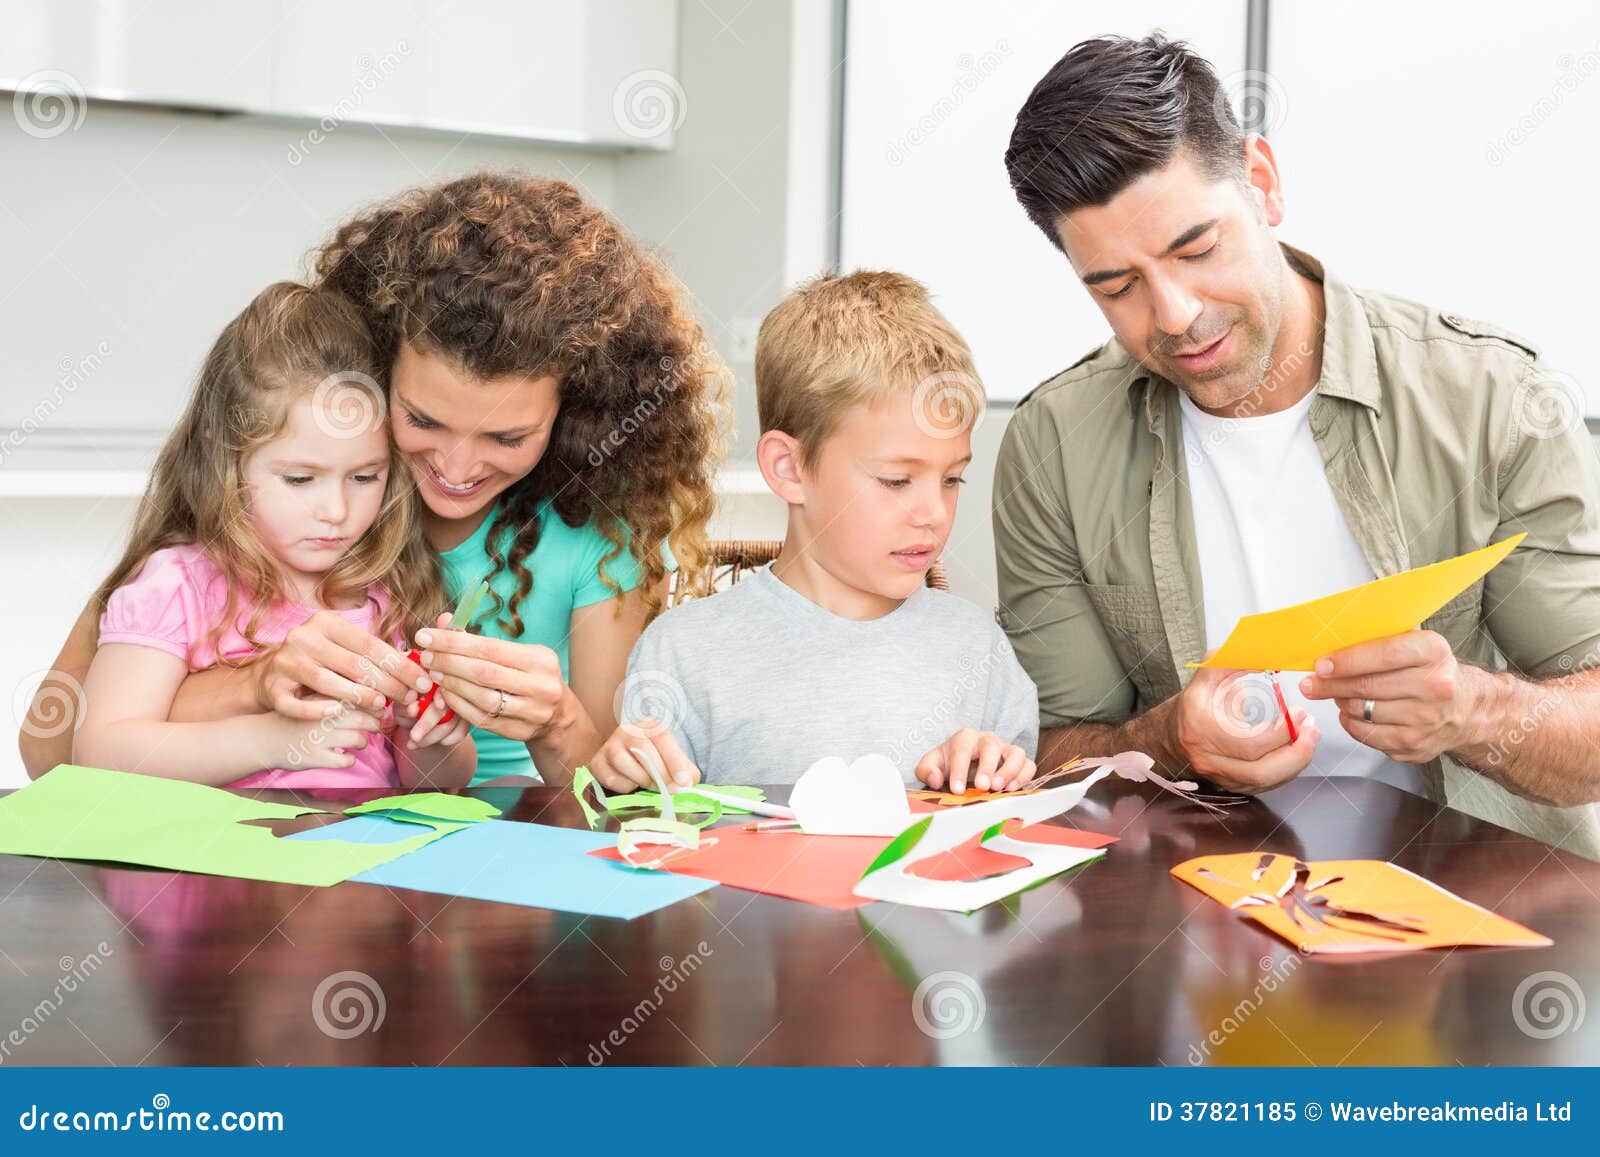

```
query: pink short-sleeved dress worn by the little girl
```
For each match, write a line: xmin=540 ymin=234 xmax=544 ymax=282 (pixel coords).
xmin=99 ymin=542 xmax=400 ymax=791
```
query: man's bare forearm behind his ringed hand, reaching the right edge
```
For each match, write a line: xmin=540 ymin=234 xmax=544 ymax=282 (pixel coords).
xmin=1450 ymin=666 xmax=1600 ymax=807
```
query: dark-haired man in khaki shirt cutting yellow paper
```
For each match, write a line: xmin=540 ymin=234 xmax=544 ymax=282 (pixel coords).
xmin=994 ymin=35 xmax=1600 ymax=858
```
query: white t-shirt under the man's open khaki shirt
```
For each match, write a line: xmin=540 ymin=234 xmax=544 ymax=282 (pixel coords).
xmin=1179 ymin=392 xmax=1426 ymax=795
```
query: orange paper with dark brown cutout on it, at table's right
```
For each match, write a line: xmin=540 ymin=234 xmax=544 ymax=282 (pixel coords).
xmin=1173 ymin=851 xmax=1552 ymax=954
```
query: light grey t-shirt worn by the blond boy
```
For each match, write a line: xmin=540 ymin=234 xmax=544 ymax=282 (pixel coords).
xmin=618 ymin=566 xmax=1038 ymax=784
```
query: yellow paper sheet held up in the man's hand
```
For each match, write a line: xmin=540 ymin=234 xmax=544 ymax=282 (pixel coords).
xmin=1189 ymin=534 xmax=1526 ymax=671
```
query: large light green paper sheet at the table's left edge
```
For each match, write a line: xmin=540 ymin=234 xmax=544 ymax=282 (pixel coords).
xmin=0 ymin=763 xmax=466 ymax=887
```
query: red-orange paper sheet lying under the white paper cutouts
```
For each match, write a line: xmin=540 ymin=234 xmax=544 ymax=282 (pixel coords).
xmin=589 ymin=824 xmax=1117 ymax=909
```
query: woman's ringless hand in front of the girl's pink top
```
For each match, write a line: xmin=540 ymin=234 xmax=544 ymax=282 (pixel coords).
xmin=254 ymin=611 xmax=429 ymax=720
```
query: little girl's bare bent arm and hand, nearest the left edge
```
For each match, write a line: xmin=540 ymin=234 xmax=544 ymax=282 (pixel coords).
xmin=72 ymin=643 xmax=376 ymax=786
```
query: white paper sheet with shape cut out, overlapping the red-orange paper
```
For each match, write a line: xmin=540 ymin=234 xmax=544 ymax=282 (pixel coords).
xmin=854 ymin=767 xmax=1112 ymax=912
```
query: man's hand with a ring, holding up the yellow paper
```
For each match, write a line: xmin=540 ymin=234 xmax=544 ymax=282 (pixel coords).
xmin=1301 ymin=631 xmax=1478 ymax=763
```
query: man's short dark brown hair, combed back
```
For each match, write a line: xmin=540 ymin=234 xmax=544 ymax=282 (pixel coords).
xmin=1005 ymin=32 xmax=1245 ymax=248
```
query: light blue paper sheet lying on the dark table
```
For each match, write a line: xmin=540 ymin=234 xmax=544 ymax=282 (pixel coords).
xmin=286 ymin=816 xmax=717 ymax=920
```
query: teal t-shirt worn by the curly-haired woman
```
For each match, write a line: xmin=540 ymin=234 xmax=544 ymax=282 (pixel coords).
xmin=442 ymin=501 xmax=643 ymax=784
